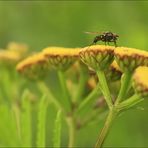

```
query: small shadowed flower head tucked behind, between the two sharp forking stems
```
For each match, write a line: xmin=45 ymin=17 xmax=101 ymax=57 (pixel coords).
xmin=105 ymin=60 xmax=122 ymax=81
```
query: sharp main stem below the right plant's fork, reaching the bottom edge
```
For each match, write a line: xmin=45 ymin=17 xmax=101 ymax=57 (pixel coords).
xmin=95 ymin=109 xmax=117 ymax=148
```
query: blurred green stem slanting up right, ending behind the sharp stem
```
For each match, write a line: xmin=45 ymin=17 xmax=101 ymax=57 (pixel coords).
xmin=77 ymin=83 xmax=100 ymax=114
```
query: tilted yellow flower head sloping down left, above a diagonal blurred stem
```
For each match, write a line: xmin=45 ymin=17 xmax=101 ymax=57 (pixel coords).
xmin=16 ymin=53 xmax=49 ymax=79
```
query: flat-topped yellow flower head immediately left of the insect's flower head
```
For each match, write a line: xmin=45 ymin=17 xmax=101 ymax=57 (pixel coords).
xmin=43 ymin=47 xmax=79 ymax=70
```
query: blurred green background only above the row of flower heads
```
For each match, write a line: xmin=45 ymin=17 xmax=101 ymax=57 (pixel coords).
xmin=0 ymin=1 xmax=148 ymax=50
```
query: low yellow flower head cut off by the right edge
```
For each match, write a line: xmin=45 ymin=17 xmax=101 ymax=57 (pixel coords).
xmin=133 ymin=66 xmax=148 ymax=97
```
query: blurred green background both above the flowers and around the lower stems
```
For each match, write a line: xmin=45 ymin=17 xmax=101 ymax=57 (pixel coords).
xmin=0 ymin=1 xmax=148 ymax=147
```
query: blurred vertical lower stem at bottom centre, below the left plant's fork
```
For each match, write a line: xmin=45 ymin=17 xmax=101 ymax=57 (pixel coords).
xmin=67 ymin=117 xmax=76 ymax=148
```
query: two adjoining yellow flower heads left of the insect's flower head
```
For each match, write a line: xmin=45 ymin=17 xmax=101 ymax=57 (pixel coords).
xmin=16 ymin=47 xmax=79 ymax=79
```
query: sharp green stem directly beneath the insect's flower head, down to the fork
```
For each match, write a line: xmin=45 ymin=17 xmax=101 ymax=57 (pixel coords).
xmin=97 ymin=70 xmax=113 ymax=110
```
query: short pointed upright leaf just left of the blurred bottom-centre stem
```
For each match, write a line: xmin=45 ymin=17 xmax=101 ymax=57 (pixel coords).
xmin=53 ymin=110 xmax=62 ymax=148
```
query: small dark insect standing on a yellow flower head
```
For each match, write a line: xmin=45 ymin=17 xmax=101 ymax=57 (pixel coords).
xmin=85 ymin=31 xmax=119 ymax=47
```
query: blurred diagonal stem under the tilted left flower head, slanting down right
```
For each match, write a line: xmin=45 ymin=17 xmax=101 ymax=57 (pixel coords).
xmin=37 ymin=81 xmax=62 ymax=109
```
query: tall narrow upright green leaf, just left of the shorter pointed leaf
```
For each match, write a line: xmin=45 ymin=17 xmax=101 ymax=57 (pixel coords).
xmin=37 ymin=95 xmax=48 ymax=147
